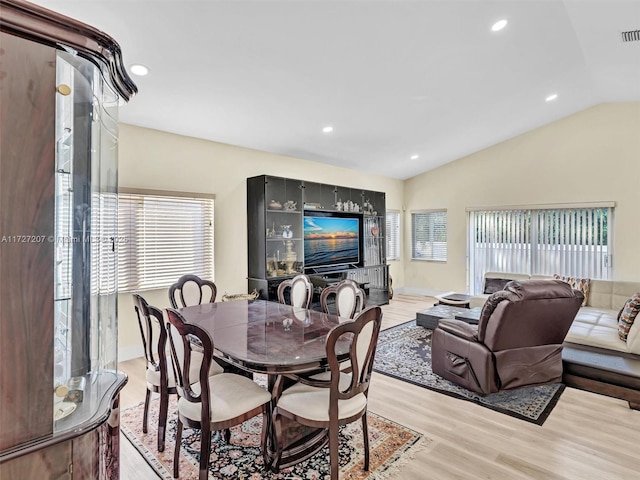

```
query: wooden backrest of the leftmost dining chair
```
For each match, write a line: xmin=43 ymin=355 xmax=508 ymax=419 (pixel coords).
xmin=133 ymin=293 xmax=168 ymax=378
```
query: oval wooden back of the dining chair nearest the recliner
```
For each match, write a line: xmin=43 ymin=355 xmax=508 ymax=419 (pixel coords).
xmin=326 ymin=306 xmax=382 ymax=402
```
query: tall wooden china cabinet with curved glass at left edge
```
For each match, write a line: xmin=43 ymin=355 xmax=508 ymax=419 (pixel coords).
xmin=0 ymin=0 xmax=136 ymax=480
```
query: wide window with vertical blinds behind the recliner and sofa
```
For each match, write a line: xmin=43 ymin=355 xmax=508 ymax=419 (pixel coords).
xmin=469 ymin=205 xmax=612 ymax=293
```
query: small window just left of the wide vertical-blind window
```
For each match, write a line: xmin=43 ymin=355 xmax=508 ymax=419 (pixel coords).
xmin=411 ymin=210 xmax=447 ymax=262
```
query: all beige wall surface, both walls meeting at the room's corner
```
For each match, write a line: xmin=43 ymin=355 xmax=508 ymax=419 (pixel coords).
xmin=119 ymin=102 xmax=640 ymax=359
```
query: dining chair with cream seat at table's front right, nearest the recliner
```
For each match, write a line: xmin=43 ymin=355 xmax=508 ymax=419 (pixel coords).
xmin=273 ymin=306 xmax=382 ymax=480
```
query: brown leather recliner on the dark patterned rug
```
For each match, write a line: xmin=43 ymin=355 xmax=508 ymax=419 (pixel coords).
xmin=431 ymin=280 xmax=584 ymax=394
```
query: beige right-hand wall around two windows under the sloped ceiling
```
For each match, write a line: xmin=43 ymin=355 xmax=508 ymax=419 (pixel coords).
xmin=403 ymin=102 xmax=640 ymax=293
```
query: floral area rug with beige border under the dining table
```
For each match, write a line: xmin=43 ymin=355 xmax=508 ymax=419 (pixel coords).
xmin=120 ymin=395 xmax=432 ymax=480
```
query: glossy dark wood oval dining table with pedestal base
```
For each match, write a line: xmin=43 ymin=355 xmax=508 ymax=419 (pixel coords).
xmin=179 ymin=300 xmax=349 ymax=469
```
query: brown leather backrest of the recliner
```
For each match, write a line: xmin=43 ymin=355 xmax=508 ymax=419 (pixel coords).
xmin=478 ymin=280 xmax=584 ymax=352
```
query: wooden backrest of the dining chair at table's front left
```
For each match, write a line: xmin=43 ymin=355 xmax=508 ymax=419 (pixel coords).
xmin=166 ymin=308 xmax=213 ymax=414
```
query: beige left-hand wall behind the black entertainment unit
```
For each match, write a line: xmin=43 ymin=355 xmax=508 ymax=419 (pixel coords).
xmin=118 ymin=125 xmax=404 ymax=359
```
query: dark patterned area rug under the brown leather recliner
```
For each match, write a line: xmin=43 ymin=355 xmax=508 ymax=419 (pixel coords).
xmin=373 ymin=320 xmax=564 ymax=425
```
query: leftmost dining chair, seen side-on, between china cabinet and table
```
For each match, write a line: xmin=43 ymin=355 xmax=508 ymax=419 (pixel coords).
xmin=133 ymin=293 xmax=177 ymax=452
